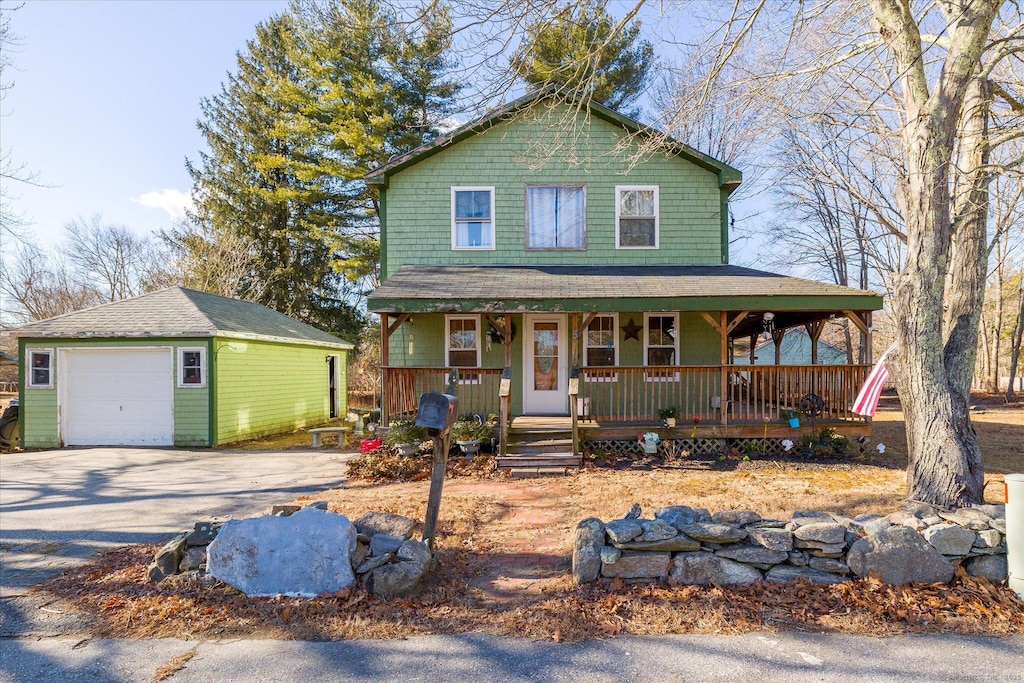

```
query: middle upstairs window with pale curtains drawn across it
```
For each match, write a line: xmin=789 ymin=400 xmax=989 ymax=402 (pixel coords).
xmin=526 ymin=185 xmax=587 ymax=249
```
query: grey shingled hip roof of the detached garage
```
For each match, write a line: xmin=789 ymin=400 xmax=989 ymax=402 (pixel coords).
xmin=11 ymin=287 xmax=352 ymax=348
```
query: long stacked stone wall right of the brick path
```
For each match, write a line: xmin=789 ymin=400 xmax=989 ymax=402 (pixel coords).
xmin=572 ymin=504 xmax=1007 ymax=586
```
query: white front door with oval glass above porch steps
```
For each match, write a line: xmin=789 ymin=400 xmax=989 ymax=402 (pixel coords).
xmin=522 ymin=314 xmax=568 ymax=415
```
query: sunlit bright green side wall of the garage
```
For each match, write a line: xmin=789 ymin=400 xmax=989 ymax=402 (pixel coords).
xmin=212 ymin=338 xmax=347 ymax=445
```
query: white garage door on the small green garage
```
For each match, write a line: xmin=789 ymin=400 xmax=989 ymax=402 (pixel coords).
xmin=57 ymin=349 xmax=174 ymax=445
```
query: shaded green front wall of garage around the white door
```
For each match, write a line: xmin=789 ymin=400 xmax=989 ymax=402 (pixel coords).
xmin=18 ymin=338 xmax=211 ymax=449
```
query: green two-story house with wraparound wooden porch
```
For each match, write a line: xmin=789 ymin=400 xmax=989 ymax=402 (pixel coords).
xmin=366 ymin=93 xmax=882 ymax=454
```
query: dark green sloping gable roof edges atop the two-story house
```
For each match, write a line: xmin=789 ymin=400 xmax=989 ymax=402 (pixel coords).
xmin=364 ymin=89 xmax=743 ymax=193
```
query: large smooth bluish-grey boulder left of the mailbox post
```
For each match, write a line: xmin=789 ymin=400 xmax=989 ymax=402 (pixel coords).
xmin=207 ymin=508 xmax=355 ymax=597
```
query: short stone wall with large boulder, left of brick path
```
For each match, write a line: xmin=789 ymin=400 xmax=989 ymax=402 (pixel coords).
xmin=150 ymin=501 xmax=432 ymax=596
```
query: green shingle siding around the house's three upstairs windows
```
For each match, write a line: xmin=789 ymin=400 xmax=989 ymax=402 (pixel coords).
xmin=382 ymin=106 xmax=727 ymax=278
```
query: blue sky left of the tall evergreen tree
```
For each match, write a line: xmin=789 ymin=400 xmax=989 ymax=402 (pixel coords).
xmin=0 ymin=0 xmax=287 ymax=246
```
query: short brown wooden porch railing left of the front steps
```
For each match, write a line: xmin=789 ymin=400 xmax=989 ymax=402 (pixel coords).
xmin=381 ymin=368 xmax=502 ymax=424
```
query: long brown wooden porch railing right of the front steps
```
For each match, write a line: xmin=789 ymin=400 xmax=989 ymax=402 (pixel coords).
xmin=580 ymin=366 xmax=870 ymax=422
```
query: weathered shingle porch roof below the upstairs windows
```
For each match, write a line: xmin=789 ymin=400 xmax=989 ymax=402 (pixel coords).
xmin=370 ymin=265 xmax=881 ymax=310
